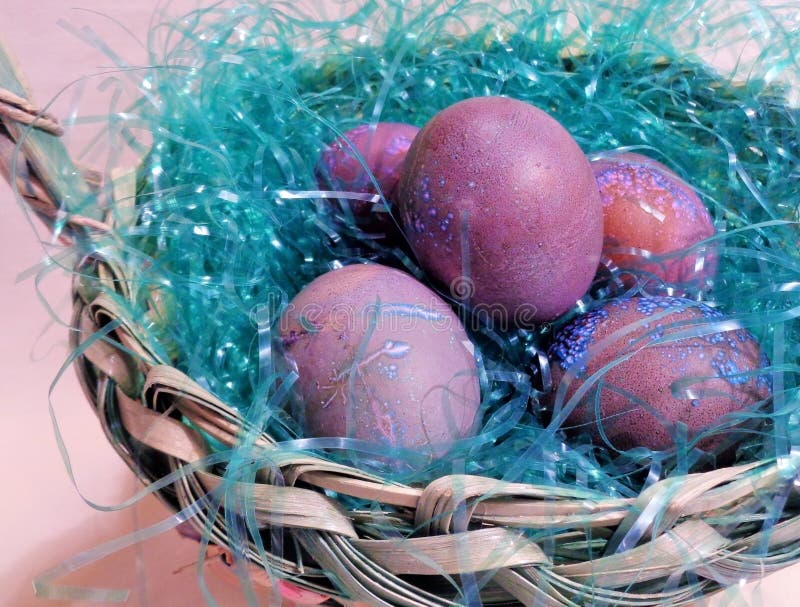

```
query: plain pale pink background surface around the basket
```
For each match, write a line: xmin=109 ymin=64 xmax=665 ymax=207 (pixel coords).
xmin=0 ymin=0 xmax=800 ymax=607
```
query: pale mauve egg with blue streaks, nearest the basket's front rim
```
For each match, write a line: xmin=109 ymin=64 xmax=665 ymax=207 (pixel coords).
xmin=280 ymin=264 xmax=480 ymax=455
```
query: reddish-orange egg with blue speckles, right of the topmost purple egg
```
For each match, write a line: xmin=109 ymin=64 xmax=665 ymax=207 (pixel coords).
xmin=592 ymin=153 xmax=717 ymax=286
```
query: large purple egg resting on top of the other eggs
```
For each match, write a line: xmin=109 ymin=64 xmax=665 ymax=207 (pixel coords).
xmin=398 ymin=97 xmax=603 ymax=326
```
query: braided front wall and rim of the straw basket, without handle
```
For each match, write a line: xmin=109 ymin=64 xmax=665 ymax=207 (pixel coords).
xmin=64 ymin=260 xmax=800 ymax=605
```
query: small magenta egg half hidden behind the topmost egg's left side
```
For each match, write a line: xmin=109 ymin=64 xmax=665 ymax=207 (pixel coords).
xmin=316 ymin=122 xmax=419 ymax=231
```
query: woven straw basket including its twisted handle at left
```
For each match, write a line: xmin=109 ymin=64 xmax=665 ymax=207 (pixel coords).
xmin=0 ymin=2 xmax=800 ymax=607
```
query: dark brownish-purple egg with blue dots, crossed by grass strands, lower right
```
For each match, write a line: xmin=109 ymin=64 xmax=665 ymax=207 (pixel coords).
xmin=549 ymin=297 xmax=771 ymax=450
